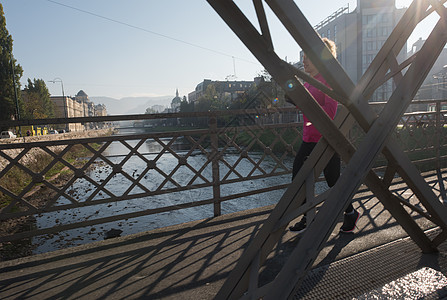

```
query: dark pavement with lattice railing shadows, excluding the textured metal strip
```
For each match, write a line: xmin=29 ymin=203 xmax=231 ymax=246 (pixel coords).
xmin=0 ymin=172 xmax=446 ymax=299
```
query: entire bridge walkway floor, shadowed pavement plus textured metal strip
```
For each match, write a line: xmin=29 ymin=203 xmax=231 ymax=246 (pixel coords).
xmin=0 ymin=191 xmax=447 ymax=300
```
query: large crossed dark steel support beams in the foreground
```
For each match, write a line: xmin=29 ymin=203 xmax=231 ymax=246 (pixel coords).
xmin=208 ymin=0 xmax=447 ymax=299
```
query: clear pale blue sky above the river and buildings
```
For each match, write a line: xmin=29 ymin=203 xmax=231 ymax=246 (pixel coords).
xmin=0 ymin=0 xmax=431 ymax=99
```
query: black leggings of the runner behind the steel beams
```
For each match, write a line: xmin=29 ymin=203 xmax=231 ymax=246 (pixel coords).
xmin=292 ymin=142 xmax=354 ymax=213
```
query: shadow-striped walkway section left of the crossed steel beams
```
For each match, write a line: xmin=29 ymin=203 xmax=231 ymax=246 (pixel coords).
xmin=0 ymin=208 xmax=271 ymax=299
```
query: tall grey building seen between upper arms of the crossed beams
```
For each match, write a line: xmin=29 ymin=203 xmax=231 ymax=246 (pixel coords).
xmin=310 ymin=0 xmax=406 ymax=101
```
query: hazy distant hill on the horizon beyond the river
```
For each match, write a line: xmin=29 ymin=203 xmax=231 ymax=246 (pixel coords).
xmin=89 ymin=96 xmax=174 ymax=115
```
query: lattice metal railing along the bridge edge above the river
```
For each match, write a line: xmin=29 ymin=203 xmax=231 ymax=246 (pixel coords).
xmin=0 ymin=100 xmax=447 ymax=242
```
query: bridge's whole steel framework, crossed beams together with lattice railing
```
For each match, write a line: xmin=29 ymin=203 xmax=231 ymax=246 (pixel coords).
xmin=0 ymin=0 xmax=447 ymax=299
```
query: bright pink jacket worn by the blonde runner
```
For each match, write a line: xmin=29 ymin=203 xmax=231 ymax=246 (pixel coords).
xmin=303 ymin=74 xmax=337 ymax=143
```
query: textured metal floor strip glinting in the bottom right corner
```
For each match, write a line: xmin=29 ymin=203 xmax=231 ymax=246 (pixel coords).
xmin=296 ymin=230 xmax=447 ymax=299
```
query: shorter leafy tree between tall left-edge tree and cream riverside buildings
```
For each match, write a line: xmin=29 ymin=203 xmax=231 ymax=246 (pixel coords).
xmin=24 ymin=78 xmax=54 ymax=119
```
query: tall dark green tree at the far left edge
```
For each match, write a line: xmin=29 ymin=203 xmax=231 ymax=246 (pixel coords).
xmin=0 ymin=3 xmax=23 ymax=130
